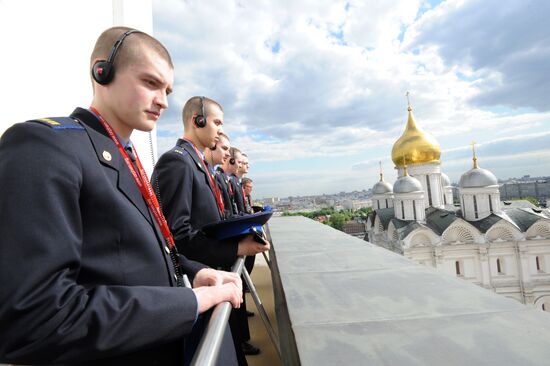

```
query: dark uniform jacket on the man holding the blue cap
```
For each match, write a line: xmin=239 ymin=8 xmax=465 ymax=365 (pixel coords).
xmin=151 ymin=139 xmax=238 ymax=269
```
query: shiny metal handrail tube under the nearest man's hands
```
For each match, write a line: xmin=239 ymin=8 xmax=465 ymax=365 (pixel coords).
xmin=191 ymin=257 xmax=248 ymax=366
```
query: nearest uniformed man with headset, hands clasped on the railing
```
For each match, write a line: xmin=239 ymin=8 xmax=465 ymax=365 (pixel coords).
xmin=0 ymin=27 xmax=242 ymax=365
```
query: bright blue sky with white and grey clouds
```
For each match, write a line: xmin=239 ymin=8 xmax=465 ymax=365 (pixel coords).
xmin=153 ymin=0 xmax=550 ymax=197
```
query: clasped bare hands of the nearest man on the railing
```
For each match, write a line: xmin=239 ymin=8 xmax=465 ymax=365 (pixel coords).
xmin=193 ymin=268 xmax=243 ymax=313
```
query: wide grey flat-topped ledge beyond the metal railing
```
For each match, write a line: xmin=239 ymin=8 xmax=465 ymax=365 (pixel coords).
xmin=269 ymin=217 xmax=550 ymax=366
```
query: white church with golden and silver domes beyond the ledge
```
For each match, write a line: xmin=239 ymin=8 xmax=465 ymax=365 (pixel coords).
xmin=365 ymin=106 xmax=550 ymax=311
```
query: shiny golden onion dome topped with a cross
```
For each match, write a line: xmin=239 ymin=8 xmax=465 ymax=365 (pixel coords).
xmin=391 ymin=105 xmax=441 ymax=167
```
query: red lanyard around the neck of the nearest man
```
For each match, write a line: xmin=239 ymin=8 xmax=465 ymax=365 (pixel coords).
xmin=90 ymin=107 xmax=174 ymax=249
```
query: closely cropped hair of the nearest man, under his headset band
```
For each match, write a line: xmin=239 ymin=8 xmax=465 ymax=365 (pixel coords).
xmin=90 ymin=27 xmax=174 ymax=71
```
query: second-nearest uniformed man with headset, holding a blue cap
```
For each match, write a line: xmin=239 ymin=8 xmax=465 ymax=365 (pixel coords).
xmin=151 ymin=96 xmax=269 ymax=365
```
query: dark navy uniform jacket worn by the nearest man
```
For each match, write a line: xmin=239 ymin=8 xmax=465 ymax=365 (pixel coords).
xmin=0 ymin=109 xmax=208 ymax=365
